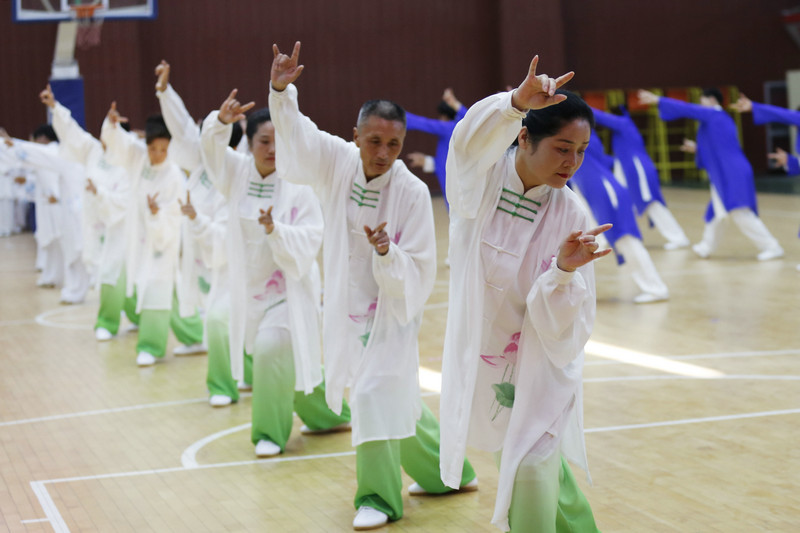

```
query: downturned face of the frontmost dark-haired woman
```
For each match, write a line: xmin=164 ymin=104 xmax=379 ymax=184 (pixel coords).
xmin=515 ymin=118 xmax=592 ymax=190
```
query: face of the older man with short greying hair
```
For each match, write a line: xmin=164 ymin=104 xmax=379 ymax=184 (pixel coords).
xmin=353 ymin=115 xmax=406 ymax=180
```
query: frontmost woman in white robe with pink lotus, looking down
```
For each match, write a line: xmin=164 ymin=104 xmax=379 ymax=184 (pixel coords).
xmin=441 ymin=56 xmax=610 ymax=533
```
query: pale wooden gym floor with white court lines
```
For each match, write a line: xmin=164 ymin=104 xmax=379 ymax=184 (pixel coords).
xmin=0 ymin=189 xmax=800 ymax=533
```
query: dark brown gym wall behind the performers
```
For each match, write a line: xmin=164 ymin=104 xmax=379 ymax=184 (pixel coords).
xmin=0 ymin=0 xmax=800 ymax=176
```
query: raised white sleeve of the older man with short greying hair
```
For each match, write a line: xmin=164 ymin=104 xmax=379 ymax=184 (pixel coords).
xmin=269 ymin=84 xmax=352 ymax=187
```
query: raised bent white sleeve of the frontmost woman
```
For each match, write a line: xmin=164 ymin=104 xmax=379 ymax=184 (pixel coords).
xmin=447 ymin=92 xmax=525 ymax=218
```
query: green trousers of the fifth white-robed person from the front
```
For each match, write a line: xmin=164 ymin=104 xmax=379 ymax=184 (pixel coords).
xmin=134 ymin=292 xmax=203 ymax=357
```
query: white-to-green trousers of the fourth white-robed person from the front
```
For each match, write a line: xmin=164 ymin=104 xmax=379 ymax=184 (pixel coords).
xmin=206 ymin=302 xmax=253 ymax=402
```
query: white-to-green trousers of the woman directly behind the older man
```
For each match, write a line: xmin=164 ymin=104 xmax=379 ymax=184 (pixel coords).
xmin=251 ymin=327 xmax=350 ymax=451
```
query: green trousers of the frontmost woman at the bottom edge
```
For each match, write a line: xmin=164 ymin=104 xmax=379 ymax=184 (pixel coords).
xmin=508 ymin=452 xmax=599 ymax=533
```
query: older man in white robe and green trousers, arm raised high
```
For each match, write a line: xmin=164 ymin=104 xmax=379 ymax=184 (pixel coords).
xmin=269 ymin=43 xmax=477 ymax=530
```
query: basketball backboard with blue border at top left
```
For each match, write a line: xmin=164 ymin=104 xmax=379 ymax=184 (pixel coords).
xmin=11 ymin=0 xmax=158 ymax=22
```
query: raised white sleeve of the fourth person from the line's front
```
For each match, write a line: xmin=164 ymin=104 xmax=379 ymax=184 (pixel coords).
xmin=156 ymin=85 xmax=200 ymax=172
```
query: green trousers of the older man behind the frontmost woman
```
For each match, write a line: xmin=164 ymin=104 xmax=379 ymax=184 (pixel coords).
xmin=354 ymin=403 xmax=475 ymax=520
